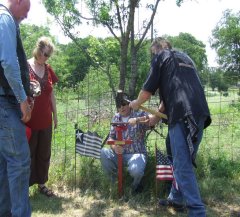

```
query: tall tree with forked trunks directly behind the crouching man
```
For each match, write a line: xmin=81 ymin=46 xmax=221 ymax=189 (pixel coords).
xmin=43 ymin=0 xmax=183 ymax=96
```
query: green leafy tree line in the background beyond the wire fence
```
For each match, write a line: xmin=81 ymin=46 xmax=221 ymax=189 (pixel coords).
xmin=21 ymin=6 xmax=240 ymax=97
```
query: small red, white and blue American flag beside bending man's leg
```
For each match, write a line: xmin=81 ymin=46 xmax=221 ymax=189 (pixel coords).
xmin=156 ymin=148 xmax=178 ymax=189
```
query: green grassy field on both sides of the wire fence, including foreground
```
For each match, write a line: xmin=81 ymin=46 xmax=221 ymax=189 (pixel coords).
xmin=30 ymin=88 xmax=240 ymax=217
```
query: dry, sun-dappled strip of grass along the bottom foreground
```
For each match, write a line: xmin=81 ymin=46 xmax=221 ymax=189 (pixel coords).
xmin=30 ymin=187 xmax=240 ymax=217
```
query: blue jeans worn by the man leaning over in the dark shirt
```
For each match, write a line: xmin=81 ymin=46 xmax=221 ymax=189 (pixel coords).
xmin=168 ymin=118 xmax=206 ymax=217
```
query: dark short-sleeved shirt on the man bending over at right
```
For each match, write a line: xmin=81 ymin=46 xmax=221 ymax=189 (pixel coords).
xmin=142 ymin=50 xmax=211 ymax=127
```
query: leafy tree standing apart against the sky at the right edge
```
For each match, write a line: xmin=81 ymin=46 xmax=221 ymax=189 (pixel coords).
xmin=210 ymin=10 xmax=240 ymax=83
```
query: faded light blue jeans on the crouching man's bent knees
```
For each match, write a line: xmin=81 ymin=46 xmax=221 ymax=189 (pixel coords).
xmin=101 ymin=148 xmax=146 ymax=190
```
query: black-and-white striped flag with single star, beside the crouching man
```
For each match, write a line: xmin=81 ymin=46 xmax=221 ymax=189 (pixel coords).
xmin=76 ymin=129 xmax=102 ymax=159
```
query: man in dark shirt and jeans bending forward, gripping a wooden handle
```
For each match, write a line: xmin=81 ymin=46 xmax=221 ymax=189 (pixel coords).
xmin=130 ymin=38 xmax=211 ymax=217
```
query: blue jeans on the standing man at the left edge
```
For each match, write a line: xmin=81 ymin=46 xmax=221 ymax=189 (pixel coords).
xmin=0 ymin=96 xmax=31 ymax=217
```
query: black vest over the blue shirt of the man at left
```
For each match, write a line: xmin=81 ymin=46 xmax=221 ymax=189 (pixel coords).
xmin=0 ymin=4 xmax=30 ymax=96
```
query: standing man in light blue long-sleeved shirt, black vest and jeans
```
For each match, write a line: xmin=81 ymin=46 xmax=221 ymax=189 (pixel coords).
xmin=0 ymin=0 xmax=31 ymax=217
